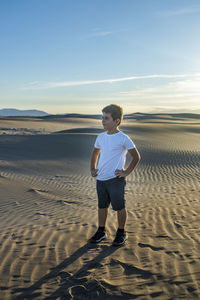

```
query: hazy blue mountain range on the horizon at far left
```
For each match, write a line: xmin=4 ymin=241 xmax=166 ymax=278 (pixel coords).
xmin=0 ymin=108 xmax=48 ymax=117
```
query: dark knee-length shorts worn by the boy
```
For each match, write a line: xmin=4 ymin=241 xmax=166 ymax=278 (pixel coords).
xmin=96 ymin=177 xmax=126 ymax=210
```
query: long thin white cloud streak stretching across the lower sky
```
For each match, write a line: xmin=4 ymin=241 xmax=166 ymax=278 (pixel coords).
xmin=21 ymin=74 xmax=199 ymax=90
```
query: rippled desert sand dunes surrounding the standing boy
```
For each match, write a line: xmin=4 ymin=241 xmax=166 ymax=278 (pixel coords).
xmin=0 ymin=114 xmax=200 ymax=300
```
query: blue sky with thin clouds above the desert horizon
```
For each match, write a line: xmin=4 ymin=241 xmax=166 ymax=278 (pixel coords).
xmin=0 ymin=0 xmax=200 ymax=114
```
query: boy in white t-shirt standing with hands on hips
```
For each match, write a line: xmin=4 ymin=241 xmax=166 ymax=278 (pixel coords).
xmin=89 ymin=104 xmax=140 ymax=246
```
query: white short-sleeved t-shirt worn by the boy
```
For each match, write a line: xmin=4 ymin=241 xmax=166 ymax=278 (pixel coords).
xmin=94 ymin=131 xmax=135 ymax=180
